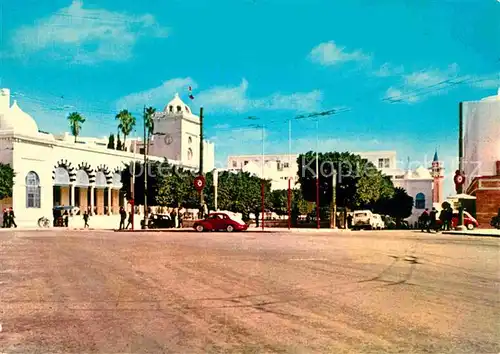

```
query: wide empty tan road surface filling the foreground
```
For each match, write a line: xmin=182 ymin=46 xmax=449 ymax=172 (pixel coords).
xmin=0 ymin=231 xmax=500 ymax=354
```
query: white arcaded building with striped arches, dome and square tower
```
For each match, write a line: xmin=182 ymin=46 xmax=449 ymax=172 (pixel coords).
xmin=0 ymin=89 xmax=215 ymax=227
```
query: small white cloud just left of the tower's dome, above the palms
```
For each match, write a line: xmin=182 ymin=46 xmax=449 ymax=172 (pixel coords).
xmin=116 ymin=77 xmax=196 ymax=110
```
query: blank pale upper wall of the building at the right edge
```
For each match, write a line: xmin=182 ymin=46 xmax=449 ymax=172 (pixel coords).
xmin=463 ymin=100 xmax=500 ymax=188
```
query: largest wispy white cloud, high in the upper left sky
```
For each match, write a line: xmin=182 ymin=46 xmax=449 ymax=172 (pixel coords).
xmin=8 ymin=0 xmax=167 ymax=64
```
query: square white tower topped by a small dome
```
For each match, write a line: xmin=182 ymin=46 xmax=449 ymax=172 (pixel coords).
xmin=150 ymin=94 xmax=200 ymax=167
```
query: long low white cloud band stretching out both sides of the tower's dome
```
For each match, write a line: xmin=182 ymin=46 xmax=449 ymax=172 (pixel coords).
xmin=117 ymin=78 xmax=323 ymax=112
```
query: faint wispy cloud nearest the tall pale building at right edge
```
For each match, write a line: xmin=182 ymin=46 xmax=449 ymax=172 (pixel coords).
xmin=384 ymin=63 xmax=465 ymax=104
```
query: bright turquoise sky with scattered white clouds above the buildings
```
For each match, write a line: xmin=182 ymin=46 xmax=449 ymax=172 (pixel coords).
xmin=0 ymin=0 xmax=500 ymax=194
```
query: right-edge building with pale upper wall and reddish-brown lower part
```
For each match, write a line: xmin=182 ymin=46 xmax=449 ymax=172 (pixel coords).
xmin=463 ymin=89 xmax=500 ymax=227
